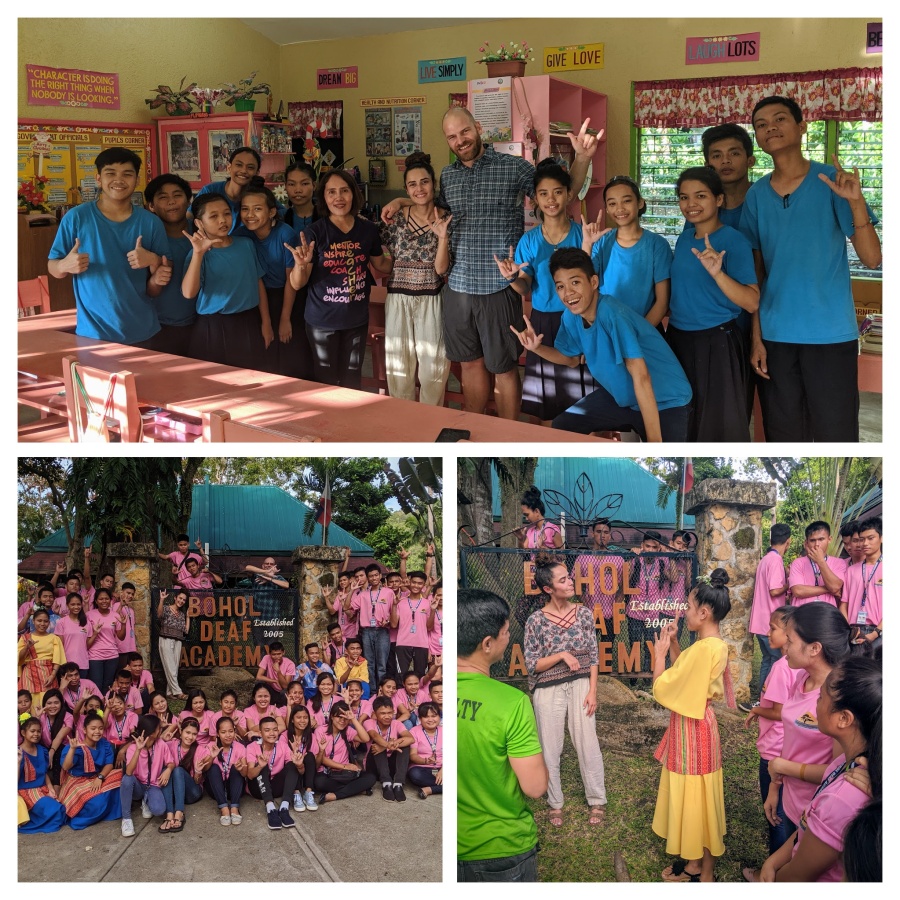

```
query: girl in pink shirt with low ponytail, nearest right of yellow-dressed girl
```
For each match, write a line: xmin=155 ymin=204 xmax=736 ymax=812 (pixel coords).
xmin=764 ymin=602 xmax=863 ymax=831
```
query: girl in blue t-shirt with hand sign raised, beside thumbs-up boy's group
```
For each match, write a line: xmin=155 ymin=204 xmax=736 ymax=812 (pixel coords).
xmin=181 ymin=193 xmax=273 ymax=369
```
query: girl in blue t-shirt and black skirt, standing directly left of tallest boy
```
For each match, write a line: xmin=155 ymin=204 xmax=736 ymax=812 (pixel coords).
xmin=666 ymin=166 xmax=759 ymax=441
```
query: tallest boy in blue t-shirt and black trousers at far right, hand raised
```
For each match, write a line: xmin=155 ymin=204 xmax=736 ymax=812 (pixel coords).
xmin=741 ymin=96 xmax=881 ymax=442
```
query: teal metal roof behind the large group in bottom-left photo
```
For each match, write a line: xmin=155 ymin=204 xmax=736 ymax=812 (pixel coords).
xmin=35 ymin=484 xmax=374 ymax=555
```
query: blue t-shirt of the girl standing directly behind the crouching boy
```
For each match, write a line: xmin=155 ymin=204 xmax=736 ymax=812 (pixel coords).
xmin=591 ymin=228 xmax=672 ymax=316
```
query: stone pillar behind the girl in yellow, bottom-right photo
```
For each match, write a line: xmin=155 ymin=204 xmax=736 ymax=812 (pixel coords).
xmin=684 ymin=478 xmax=776 ymax=701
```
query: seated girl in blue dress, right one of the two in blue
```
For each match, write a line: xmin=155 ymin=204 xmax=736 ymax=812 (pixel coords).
xmin=59 ymin=712 xmax=123 ymax=831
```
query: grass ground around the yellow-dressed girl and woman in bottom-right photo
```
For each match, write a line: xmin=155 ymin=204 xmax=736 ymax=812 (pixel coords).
xmin=531 ymin=647 xmax=768 ymax=882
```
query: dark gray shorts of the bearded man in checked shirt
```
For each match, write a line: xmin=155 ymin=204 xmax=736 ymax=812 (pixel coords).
xmin=444 ymin=287 xmax=525 ymax=375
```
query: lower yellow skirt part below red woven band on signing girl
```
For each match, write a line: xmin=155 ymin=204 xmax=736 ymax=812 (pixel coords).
xmin=653 ymin=767 xmax=725 ymax=859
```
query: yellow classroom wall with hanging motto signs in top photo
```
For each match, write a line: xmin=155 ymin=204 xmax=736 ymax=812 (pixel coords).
xmin=19 ymin=17 xmax=882 ymax=189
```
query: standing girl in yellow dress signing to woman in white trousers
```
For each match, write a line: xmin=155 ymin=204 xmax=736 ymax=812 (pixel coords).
xmin=653 ymin=569 xmax=734 ymax=881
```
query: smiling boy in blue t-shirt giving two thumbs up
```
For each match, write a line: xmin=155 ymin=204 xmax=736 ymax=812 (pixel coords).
xmin=47 ymin=147 xmax=167 ymax=349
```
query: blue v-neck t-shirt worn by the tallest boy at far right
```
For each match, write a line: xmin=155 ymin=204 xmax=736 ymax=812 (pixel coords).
xmin=741 ymin=162 xmax=878 ymax=344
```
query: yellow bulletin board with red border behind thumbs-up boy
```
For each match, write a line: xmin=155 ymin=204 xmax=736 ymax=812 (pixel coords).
xmin=16 ymin=119 xmax=156 ymax=207
